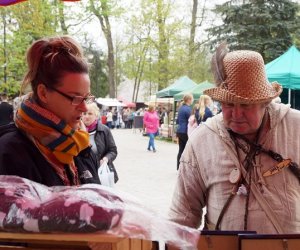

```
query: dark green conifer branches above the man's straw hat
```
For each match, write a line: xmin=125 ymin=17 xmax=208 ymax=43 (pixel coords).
xmin=208 ymin=0 xmax=300 ymax=63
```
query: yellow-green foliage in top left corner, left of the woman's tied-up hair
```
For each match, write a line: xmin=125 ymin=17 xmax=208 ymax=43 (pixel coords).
xmin=0 ymin=0 xmax=57 ymax=96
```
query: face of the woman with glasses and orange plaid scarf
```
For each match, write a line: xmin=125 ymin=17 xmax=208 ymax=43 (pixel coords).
xmin=42 ymin=73 xmax=90 ymax=129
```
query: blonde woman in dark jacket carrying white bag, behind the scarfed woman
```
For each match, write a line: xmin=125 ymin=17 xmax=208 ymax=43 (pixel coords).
xmin=82 ymin=103 xmax=119 ymax=183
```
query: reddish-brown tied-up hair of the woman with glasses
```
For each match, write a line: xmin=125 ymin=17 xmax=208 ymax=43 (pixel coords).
xmin=21 ymin=36 xmax=88 ymax=98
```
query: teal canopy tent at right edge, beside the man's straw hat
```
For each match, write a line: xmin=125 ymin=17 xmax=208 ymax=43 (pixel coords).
xmin=266 ymin=45 xmax=300 ymax=106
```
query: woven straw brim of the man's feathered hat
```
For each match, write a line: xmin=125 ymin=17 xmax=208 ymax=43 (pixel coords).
xmin=203 ymin=82 xmax=282 ymax=104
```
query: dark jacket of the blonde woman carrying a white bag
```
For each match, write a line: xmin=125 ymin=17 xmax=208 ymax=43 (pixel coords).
xmin=95 ymin=122 xmax=119 ymax=182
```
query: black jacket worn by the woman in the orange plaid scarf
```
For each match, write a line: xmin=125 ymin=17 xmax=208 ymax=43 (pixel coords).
xmin=0 ymin=124 xmax=100 ymax=186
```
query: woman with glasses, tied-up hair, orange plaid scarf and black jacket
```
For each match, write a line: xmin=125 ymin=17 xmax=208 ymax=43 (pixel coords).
xmin=0 ymin=36 xmax=100 ymax=186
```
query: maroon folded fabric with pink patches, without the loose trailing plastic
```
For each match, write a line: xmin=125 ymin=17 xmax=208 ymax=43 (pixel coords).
xmin=0 ymin=176 xmax=123 ymax=233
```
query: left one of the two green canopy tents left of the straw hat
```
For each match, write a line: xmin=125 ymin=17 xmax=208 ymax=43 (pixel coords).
xmin=156 ymin=76 xmax=197 ymax=98
